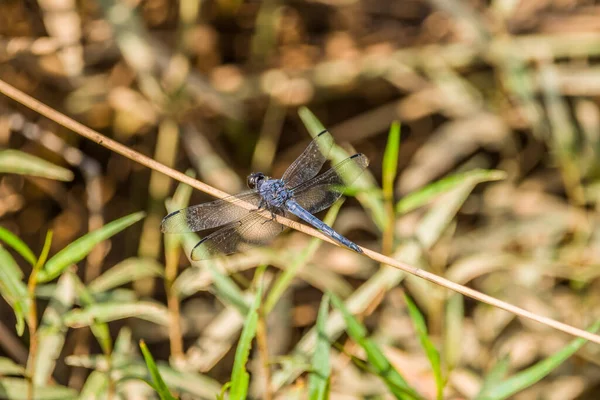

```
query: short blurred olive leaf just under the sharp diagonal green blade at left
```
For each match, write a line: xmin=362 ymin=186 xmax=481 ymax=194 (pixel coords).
xmin=88 ymin=257 xmax=163 ymax=293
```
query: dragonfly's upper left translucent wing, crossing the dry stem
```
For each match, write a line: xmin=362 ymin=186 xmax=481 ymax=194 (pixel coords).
xmin=160 ymin=191 xmax=261 ymax=233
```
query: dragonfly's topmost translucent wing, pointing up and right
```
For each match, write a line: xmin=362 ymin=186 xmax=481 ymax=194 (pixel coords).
xmin=281 ymin=131 xmax=333 ymax=189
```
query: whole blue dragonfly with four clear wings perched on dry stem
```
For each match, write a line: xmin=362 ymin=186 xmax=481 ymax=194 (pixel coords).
xmin=161 ymin=131 xmax=369 ymax=260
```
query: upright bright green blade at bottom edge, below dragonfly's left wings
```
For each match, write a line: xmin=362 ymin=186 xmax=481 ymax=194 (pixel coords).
xmin=229 ymin=284 xmax=262 ymax=400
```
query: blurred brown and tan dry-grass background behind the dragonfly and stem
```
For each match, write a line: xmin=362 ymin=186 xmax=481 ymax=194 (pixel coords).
xmin=0 ymin=0 xmax=600 ymax=399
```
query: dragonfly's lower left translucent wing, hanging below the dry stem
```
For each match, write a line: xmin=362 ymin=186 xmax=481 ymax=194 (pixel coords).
xmin=192 ymin=210 xmax=285 ymax=260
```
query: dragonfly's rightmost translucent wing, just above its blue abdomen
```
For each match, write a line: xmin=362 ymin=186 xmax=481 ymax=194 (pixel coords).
xmin=292 ymin=154 xmax=369 ymax=214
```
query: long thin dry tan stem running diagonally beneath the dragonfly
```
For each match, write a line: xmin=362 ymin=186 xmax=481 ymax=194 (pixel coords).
xmin=0 ymin=80 xmax=600 ymax=344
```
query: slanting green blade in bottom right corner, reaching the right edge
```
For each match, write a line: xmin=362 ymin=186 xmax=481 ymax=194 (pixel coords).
xmin=477 ymin=321 xmax=600 ymax=400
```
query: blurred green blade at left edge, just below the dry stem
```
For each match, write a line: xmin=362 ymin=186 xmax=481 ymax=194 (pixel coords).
xmin=0 ymin=149 xmax=73 ymax=181
